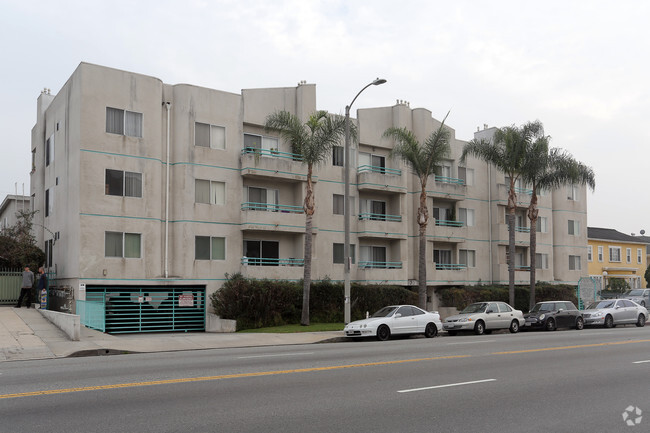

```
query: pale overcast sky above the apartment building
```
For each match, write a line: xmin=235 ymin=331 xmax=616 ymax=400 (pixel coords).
xmin=0 ymin=0 xmax=650 ymax=234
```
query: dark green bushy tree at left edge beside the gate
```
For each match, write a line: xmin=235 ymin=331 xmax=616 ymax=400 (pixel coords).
xmin=0 ymin=210 xmax=45 ymax=269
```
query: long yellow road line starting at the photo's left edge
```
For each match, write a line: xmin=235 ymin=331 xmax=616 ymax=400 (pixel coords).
xmin=0 ymin=355 xmax=471 ymax=400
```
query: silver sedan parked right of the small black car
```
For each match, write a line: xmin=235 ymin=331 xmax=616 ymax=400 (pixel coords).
xmin=582 ymin=299 xmax=648 ymax=328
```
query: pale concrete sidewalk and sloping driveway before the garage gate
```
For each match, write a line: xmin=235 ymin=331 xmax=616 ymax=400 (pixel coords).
xmin=0 ymin=306 xmax=344 ymax=361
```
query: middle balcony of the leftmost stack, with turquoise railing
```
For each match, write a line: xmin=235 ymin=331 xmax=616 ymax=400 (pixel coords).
xmin=241 ymin=202 xmax=308 ymax=233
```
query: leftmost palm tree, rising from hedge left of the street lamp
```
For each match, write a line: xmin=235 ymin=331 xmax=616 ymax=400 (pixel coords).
xmin=264 ymin=110 xmax=345 ymax=326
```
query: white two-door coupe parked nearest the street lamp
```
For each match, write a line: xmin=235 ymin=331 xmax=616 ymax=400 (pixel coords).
xmin=343 ymin=305 xmax=442 ymax=341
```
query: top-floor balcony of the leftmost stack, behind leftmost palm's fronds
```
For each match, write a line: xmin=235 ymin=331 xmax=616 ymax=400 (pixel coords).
xmin=240 ymin=147 xmax=318 ymax=182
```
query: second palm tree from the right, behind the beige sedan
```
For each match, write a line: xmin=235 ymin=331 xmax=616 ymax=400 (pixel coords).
xmin=460 ymin=121 xmax=544 ymax=305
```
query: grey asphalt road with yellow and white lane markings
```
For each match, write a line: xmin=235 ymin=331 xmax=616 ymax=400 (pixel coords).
xmin=0 ymin=327 xmax=650 ymax=433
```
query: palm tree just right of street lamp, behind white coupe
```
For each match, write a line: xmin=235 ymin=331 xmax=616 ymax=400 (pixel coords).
xmin=384 ymin=113 xmax=450 ymax=309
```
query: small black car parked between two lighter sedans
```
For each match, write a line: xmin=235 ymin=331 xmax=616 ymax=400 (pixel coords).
xmin=524 ymin=301 xmax=585 ymax=331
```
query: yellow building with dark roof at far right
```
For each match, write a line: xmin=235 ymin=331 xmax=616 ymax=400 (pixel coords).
xmin=587 ymin=227 xmax=648 ymax=289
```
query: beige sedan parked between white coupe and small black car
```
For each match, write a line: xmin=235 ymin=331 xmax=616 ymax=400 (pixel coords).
xmin=442 ymin=302 xmax=526 ymax=335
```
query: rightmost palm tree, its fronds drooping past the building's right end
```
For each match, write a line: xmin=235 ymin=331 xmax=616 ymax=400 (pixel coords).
xmin=522 ymin=137 xmax=596 ymax=309
